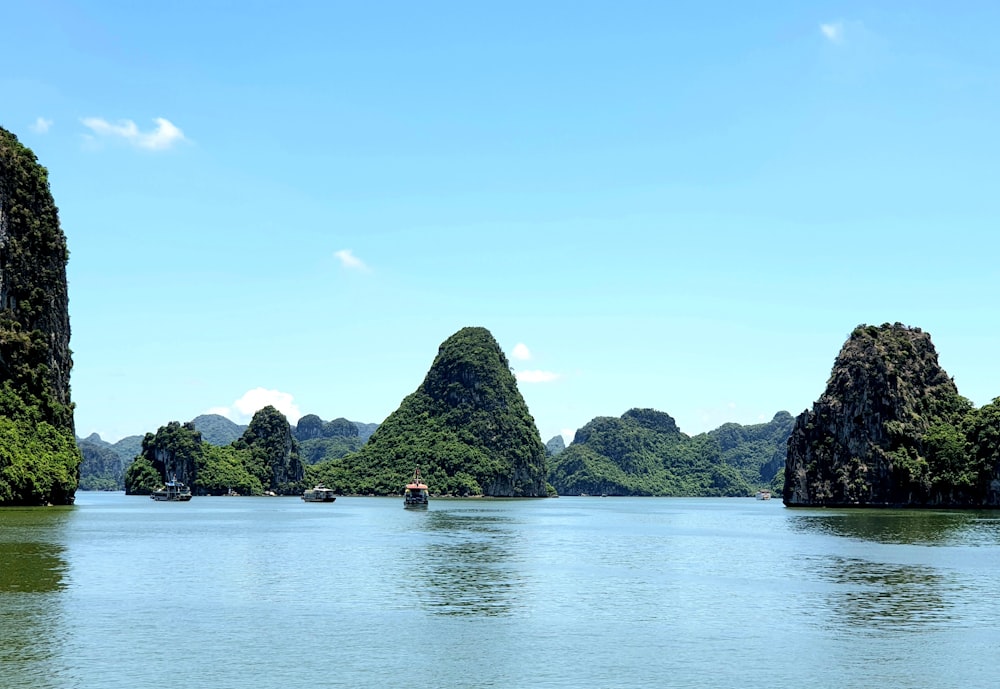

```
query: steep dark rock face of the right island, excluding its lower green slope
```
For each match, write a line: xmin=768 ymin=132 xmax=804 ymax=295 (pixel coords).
xmin=784 ymin=323 xmax=970 ymax=506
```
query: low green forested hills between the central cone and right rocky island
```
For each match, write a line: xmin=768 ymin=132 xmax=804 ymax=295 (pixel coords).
xmin=549 ymin=409 xmax=791 ymax=496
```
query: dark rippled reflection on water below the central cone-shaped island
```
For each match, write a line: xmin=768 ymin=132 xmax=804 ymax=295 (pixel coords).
xmin=416 ymin=510 xmax=521 ymax=617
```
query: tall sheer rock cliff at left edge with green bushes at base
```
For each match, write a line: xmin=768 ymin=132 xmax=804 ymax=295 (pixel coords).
xmin=0 ymin=128 xmax=81 ymax=504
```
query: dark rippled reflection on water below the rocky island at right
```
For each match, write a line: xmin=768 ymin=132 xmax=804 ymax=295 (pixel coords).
xmin=788 ymin=509 xmax=1000 ymax=638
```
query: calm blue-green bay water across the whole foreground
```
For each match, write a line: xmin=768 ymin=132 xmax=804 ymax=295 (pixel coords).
xmin=0 ymin=493 xmax=1000 ymax=689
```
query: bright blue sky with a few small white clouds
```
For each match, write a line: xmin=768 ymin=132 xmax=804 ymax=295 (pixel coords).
xmin=0 ymin=0 xmax=1000 ymax=442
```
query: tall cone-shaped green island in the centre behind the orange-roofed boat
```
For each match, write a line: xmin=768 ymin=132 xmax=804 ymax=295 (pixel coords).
xmin=309 ymin=328 xmax=548 ymax=497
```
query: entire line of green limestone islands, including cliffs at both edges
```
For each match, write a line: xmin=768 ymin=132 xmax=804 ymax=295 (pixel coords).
xmin=0 ymin=128 xmax=1000 ymax=508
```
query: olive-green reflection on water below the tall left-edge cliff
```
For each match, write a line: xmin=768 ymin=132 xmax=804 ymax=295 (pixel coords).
xmin=0 ymin=507 xmax=73 ymax=687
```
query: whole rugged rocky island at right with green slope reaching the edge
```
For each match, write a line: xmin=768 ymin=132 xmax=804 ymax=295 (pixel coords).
xmin=784 ymin=323 xmax=1000 ymax=507
